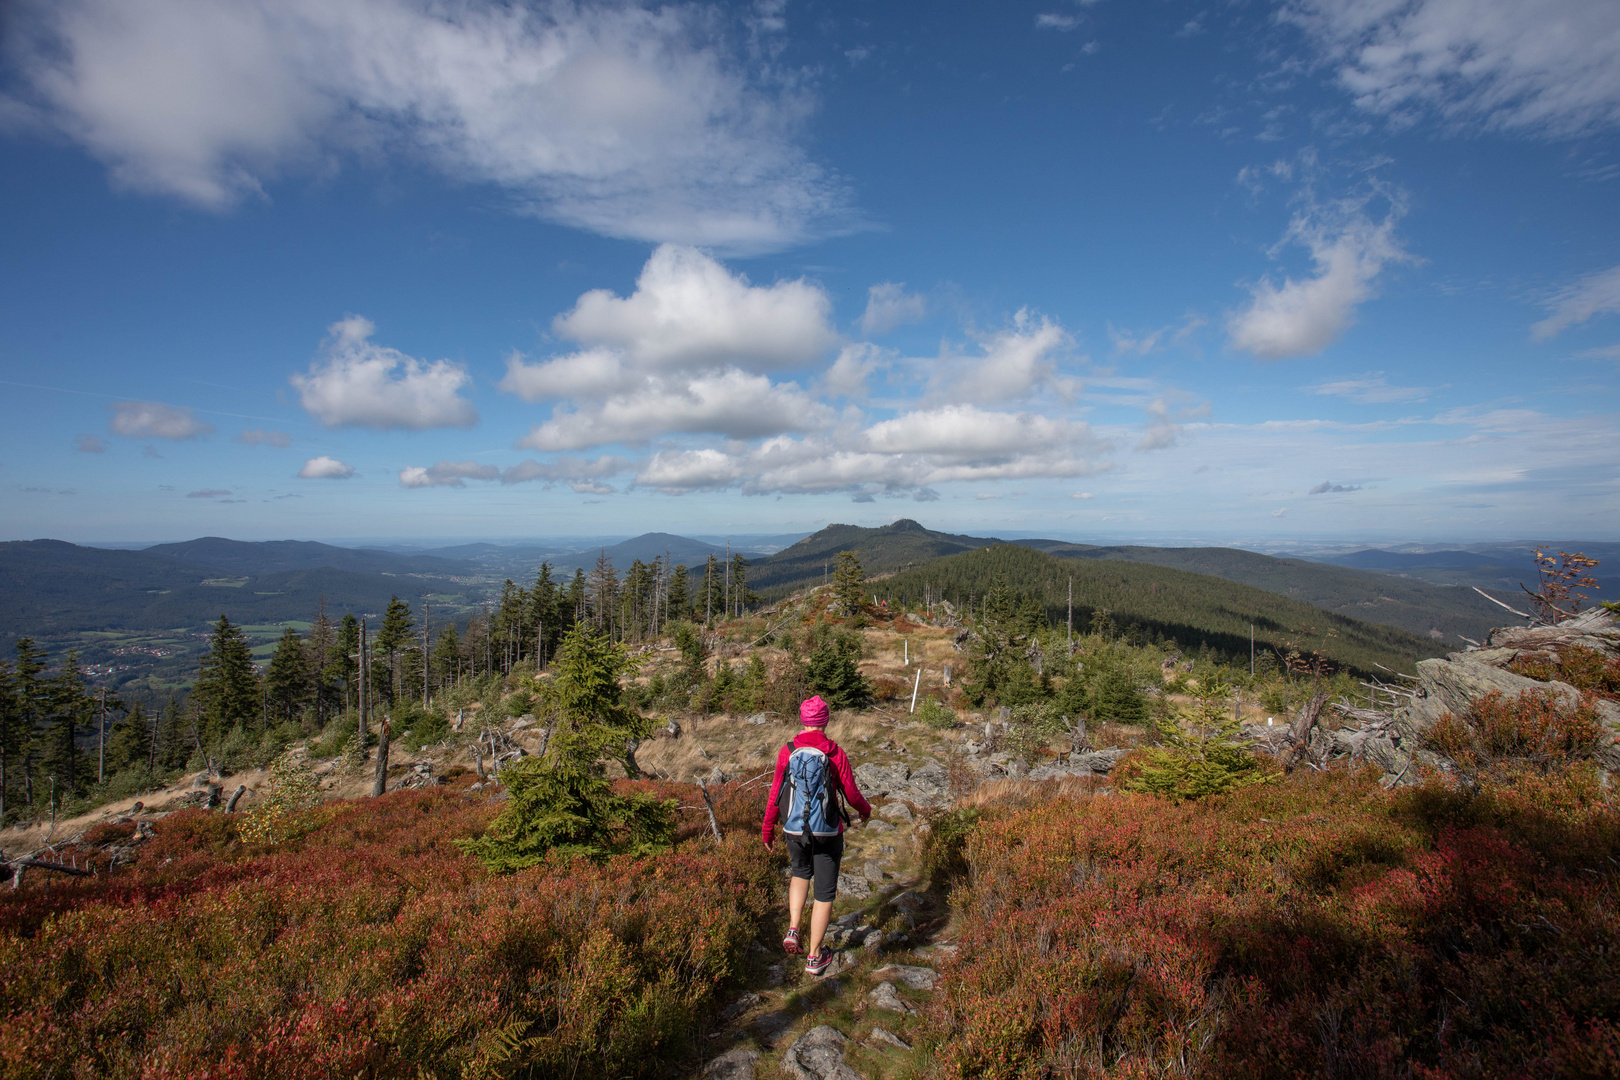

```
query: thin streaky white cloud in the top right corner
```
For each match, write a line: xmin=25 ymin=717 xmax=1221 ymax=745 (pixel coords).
xmin=1280 ymin=0 xmax=1620 ymax=136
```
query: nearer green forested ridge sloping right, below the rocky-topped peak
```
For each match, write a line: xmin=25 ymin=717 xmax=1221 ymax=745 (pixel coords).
xmin=868 ymin=544 xmax=1448 ymax=672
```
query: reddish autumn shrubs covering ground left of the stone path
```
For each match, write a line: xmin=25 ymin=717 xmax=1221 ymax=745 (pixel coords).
xmin=0 ymin=785 xmax=774 ymax=1080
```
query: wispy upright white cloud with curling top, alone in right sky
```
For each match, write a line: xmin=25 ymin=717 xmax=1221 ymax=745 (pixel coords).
xmin=1226 ymin=202 xmax=1408 ymax=359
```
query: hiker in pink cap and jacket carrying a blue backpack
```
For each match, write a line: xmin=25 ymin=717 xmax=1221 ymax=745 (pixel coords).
xmin=763 ymin=696 xmax=872 ymax=975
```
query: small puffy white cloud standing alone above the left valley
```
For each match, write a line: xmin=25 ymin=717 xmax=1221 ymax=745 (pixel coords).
xmin=288 ymin=316 xmax=478 ymax=431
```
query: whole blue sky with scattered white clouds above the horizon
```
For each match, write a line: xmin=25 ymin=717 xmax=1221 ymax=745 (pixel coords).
xmin=0 ymin=0 xmax=1620 ymax=544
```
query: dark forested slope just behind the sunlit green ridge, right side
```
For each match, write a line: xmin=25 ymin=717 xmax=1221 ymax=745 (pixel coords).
xmin=1013 ymin=539 xmax=1513 ymax=649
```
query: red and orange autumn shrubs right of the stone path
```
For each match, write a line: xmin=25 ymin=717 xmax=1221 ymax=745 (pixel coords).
xmin=933 ymin=698 xmax=1620 ymax=1080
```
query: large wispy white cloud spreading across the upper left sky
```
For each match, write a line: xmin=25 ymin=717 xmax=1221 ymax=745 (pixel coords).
xmin=5 ymin=0 xmax=849 ymax=251
